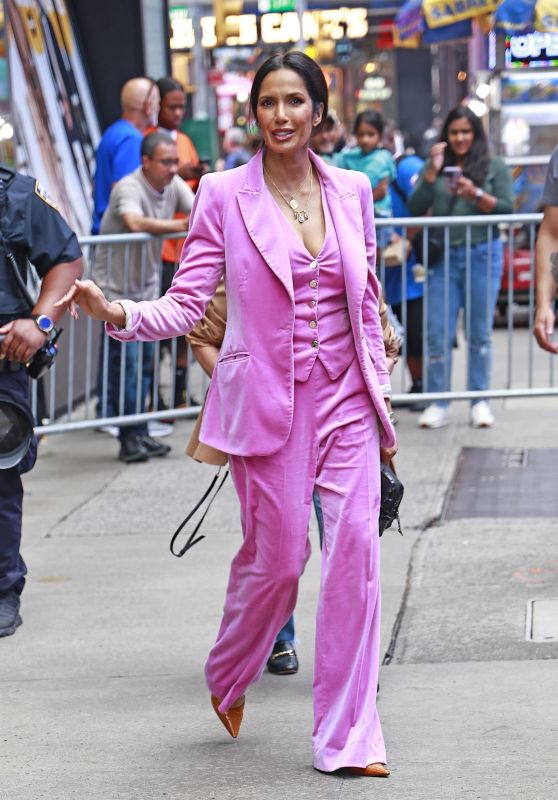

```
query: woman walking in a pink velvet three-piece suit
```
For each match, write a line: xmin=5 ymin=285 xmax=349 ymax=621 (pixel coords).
xmin=60 ymin=52 xmax=396 ymax=776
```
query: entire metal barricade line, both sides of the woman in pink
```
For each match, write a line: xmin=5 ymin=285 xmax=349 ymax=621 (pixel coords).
xmin=32 ymin=214 xmax=558 ymax=433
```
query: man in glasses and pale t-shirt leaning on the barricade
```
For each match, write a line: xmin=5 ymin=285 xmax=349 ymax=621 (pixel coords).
xmin=93 ymin=131 xmax=194 ymax=463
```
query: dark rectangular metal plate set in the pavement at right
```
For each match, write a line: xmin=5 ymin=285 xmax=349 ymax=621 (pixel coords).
xmin=444 ymin=447 xmax=558 ymax=519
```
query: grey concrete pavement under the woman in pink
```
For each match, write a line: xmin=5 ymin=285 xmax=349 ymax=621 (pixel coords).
xmin=0 ymin=400 xmax=558 ymax=800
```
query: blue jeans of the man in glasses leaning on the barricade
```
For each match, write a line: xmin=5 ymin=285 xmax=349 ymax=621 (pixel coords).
xmin=103 ymin=339 xmax=155 ymax=439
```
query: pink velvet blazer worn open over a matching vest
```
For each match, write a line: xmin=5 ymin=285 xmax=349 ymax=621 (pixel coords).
xmin=107 ymin=146 xmax=395 ymax=456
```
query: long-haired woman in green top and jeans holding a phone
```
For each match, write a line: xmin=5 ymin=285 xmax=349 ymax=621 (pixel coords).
xmin=408 ymin=106 xmax=513 ymax=428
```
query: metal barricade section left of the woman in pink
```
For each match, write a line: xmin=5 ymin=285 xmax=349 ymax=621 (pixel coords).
xmin=31 ymin=233 xmax=208 ymax=434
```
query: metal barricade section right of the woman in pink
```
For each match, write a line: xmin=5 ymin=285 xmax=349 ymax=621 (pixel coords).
xmin=376 ymin=214 xmax=558 ymax=405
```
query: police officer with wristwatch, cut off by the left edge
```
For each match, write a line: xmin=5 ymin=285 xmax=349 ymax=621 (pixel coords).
xmin=0 ymin=164 xmax=83 ymax=637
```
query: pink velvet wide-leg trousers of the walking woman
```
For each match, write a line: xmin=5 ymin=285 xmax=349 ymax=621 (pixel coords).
xmin=206 ymin=358 xmax=386 ymax=772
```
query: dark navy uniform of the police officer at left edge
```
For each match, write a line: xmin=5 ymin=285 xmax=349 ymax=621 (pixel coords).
xmin=0 ymin=165 xmax=81 ymax=608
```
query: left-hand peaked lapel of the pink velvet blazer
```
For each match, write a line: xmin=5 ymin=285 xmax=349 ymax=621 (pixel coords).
xmin=236 ymin=150 xmax=294 ymax=303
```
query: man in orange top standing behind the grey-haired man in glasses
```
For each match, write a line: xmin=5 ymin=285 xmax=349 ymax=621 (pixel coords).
xmin=145 ymin=78 xmax=207 ymax=406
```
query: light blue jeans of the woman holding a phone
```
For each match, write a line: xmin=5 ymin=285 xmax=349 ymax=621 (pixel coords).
xmin=426 ymin=239 xmax=503 ymax=406
